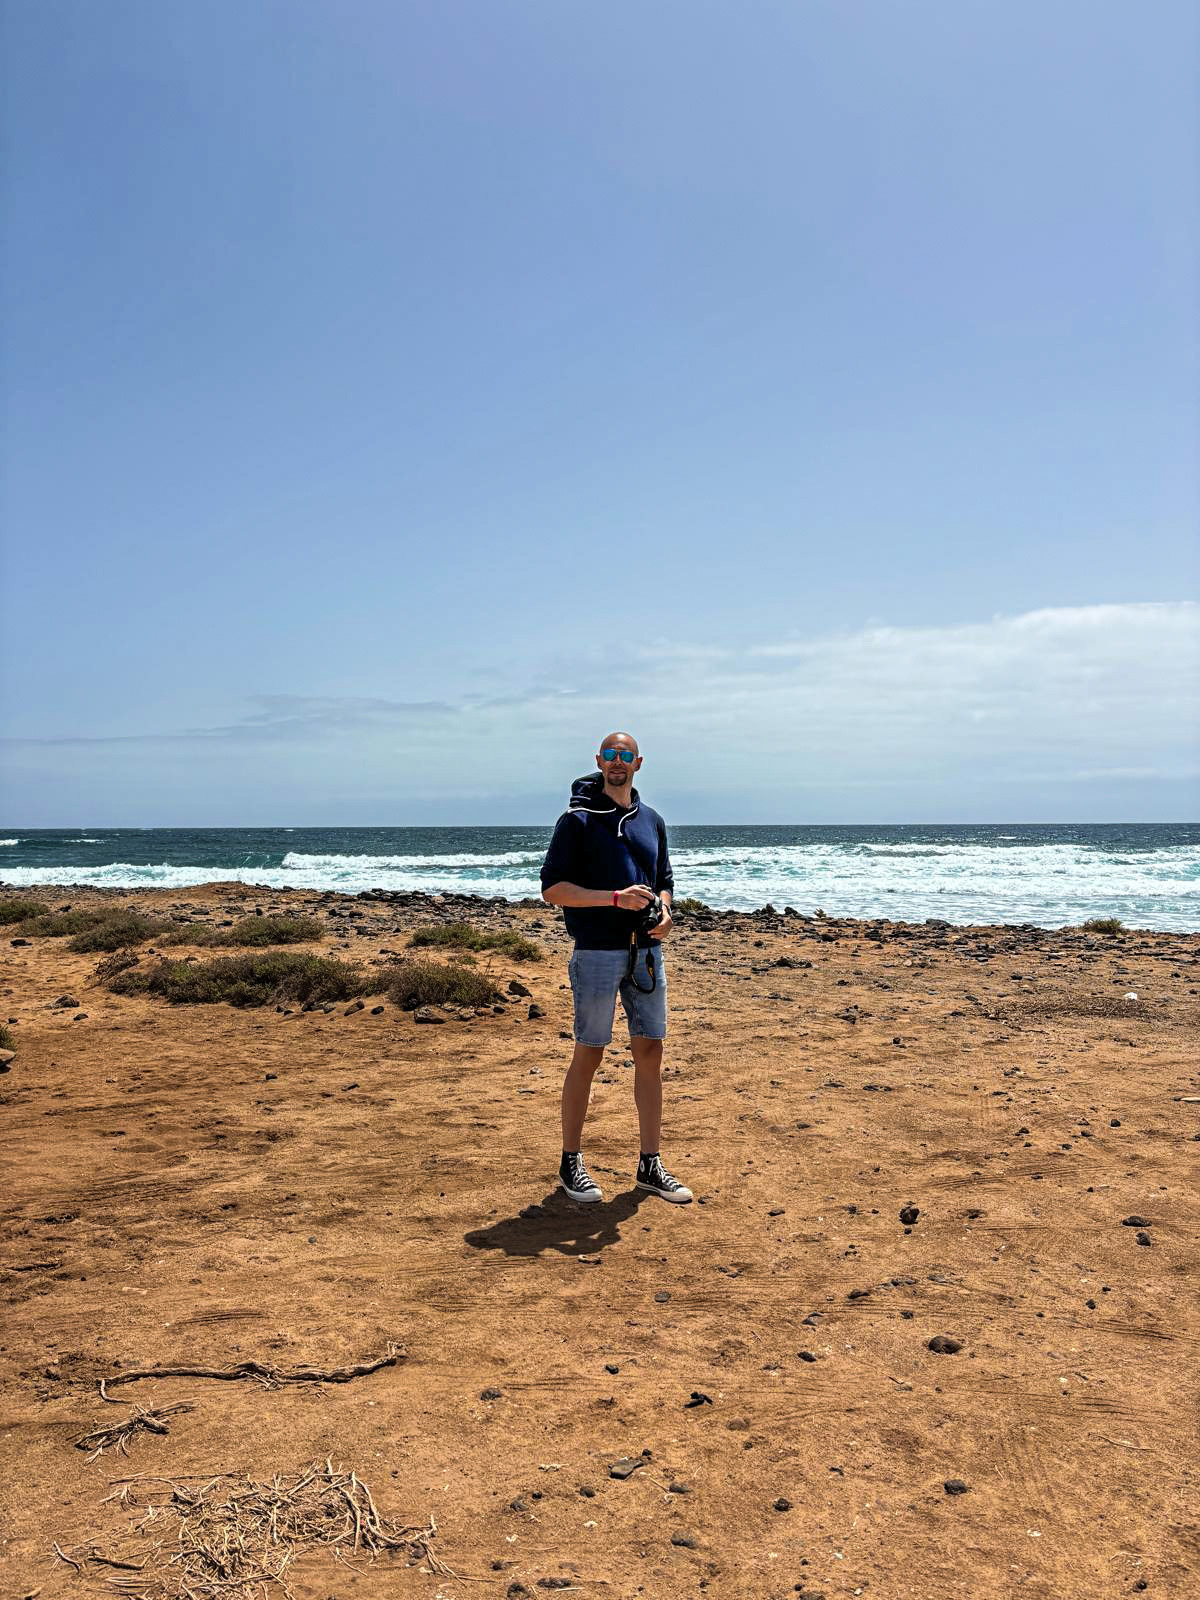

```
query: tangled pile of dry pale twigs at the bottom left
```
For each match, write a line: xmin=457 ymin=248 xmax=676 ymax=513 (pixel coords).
xmin=54 ymin=1458 xmax=454 ymax=1600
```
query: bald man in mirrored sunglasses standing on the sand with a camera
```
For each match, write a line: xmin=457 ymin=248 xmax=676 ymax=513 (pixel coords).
xmin=542 ymin=733 xmax=691 ymax=1205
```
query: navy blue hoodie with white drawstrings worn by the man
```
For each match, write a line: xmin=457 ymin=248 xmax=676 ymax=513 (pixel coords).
xmin=542 ymin=771 xmax=675 ymax=950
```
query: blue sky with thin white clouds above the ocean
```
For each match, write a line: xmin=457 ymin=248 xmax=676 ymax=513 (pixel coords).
xmin=0 ymin=0 xmax=1200 ymax=829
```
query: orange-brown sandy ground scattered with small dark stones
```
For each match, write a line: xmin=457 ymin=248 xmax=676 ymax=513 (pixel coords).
xmin=0 ymin=885 xmax=1200 ymax=1600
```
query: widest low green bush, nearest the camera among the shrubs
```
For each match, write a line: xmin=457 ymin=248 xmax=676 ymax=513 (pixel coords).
xmin=109 ymin=950 xmax=376 ymax=1006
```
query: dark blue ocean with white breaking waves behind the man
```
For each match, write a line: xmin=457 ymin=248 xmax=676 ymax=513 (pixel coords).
xmin=0 ymin=822 xmax=1200 ymax=931
